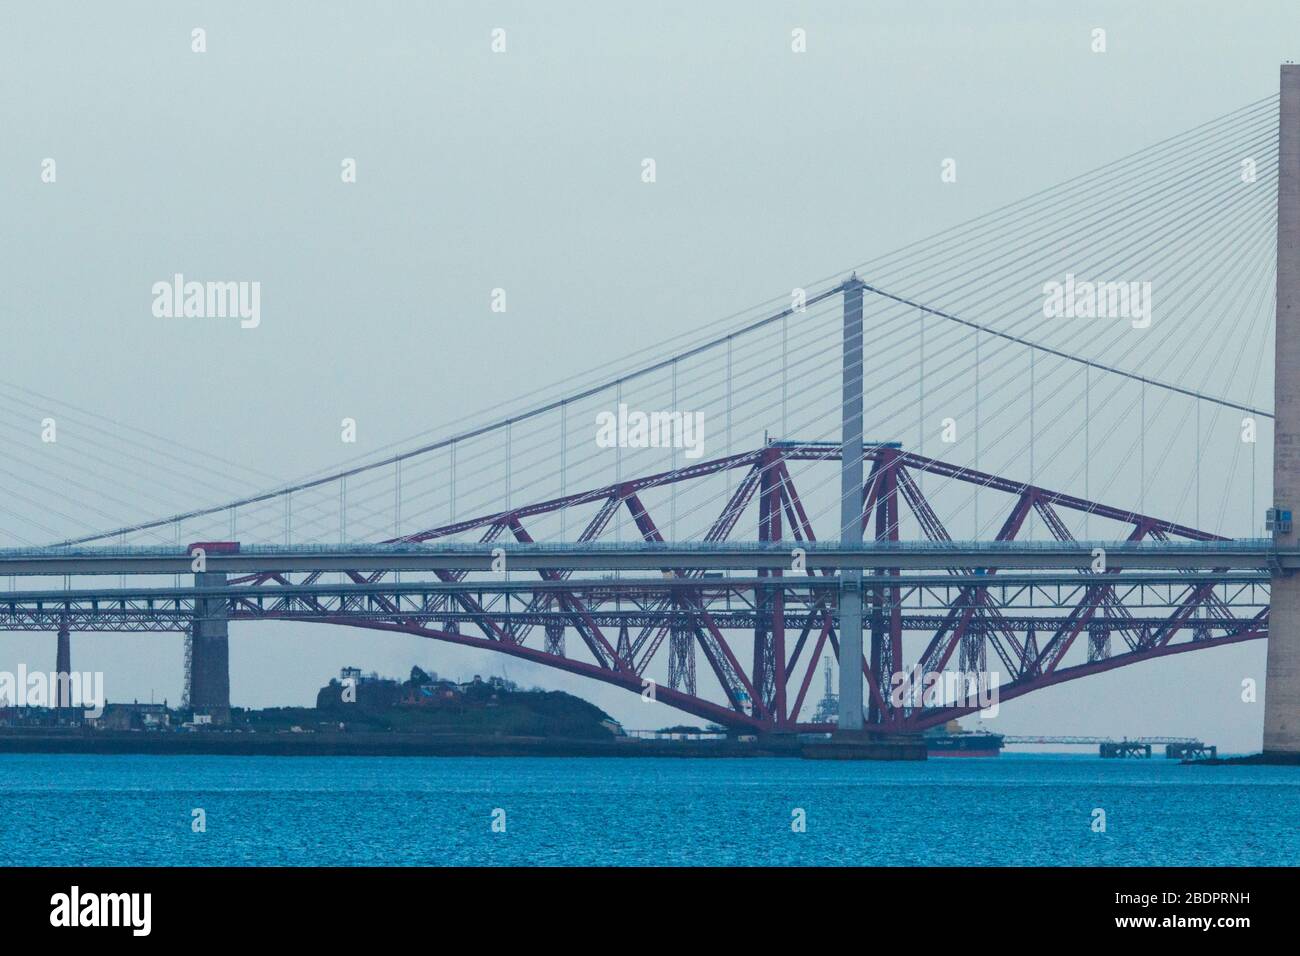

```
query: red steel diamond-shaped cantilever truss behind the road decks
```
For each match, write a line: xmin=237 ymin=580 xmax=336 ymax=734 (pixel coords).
xmin=231 ymin=442 xmax=1268 ymax=734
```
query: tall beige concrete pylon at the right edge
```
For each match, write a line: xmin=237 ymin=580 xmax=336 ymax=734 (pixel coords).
xmin=1268 ymin=64 xmax=1300 ymax=754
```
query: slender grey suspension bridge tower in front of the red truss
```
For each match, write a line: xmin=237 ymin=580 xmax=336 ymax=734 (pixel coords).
xmin=839 ymin=276 xmax=862 ymax=734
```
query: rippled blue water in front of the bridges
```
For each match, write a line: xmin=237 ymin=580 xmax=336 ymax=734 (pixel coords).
xmin=0 ymin=754 xmax=1300 ymax=866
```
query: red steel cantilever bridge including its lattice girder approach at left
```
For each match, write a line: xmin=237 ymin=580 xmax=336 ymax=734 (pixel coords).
xmin=12 ymin=442 xmax=1268 ymax=732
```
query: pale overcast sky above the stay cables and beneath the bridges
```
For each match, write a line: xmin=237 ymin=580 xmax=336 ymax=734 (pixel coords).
xmin=0 ymin=0 xmax=1300 ymax=749
